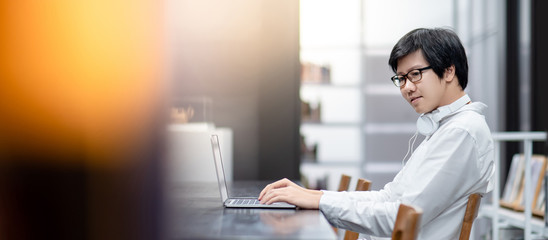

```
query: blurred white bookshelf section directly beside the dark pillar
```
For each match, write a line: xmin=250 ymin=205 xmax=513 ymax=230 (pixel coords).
xmin=299 ymin=0 xmax=363 ymax=190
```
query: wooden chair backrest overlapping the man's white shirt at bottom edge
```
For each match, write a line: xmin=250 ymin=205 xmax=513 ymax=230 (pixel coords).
xmin=392 ymin=203 xmax=422 ymax=240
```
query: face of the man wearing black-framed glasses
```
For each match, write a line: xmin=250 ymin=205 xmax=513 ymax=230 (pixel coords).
xmin=396 ymin=50 xmax=446 ymax=113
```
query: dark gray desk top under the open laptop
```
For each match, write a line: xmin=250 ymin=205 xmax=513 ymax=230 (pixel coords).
xmin=166 ymin=182 xmax=337 ymax=240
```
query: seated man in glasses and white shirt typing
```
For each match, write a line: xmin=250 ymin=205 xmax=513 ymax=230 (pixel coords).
xmin=259 ymin=29 xmax=494 ymax=240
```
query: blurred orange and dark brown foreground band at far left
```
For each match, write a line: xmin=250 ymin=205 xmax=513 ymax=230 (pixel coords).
xmin=0 ymin=0 xmax=167 ymax=240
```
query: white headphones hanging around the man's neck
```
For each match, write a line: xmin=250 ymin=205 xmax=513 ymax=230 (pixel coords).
xmin=417 ymin=94 xmax=470 ymax=136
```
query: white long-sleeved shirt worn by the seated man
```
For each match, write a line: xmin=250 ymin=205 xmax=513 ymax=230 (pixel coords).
xmin=320 ymin=102 xmax=495 ymax=240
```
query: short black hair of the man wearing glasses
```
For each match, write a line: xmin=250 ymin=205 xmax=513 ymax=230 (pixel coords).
xmin=388 ymin=28 xmax=468 ymax=90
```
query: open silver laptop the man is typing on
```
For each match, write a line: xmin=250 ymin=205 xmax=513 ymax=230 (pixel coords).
xmin=211 ymin=135 xmax=296 ymax=208
